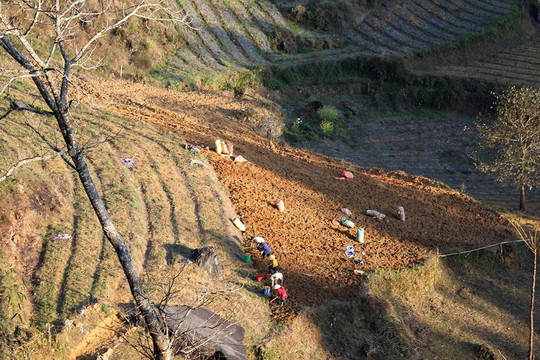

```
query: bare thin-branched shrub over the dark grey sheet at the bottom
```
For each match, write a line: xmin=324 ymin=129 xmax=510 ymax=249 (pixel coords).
xmin=111 ymin=263 xmax=253 ymax=359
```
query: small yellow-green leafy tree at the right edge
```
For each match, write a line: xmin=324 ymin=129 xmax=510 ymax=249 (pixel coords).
xmin=477 ymin=87 xmax=540 ymax=210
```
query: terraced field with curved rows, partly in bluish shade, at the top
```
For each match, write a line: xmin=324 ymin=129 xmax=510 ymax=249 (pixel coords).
xmin=161 ymin=0 xmax=519 ymax=80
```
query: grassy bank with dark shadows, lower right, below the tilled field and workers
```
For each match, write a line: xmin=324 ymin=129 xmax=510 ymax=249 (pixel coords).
xmin=278 ymin=252 xmax=540 ymax=359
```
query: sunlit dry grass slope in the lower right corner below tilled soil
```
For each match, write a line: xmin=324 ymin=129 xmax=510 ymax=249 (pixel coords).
xmin=368 ymin=252 xmax=538 ymax=359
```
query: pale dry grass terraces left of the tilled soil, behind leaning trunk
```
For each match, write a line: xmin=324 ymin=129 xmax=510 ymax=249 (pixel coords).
xmin=0 ymin=80 xmax=270 ymax=359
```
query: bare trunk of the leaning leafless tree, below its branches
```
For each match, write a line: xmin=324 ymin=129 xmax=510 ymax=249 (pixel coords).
xmin=72 ymin=149 xmax=172 ymax=360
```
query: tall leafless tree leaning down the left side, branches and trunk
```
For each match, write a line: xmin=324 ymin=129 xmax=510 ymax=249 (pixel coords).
xmin=0 ymin=0 xmax=185 ymax=359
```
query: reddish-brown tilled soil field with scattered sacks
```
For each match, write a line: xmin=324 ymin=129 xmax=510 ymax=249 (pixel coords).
xmin=86 ymin=80 xmax=513 ymax=319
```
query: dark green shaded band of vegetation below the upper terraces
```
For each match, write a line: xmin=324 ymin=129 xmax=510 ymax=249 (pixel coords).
xmin=263 ymin=57 xmax=500 ymax=113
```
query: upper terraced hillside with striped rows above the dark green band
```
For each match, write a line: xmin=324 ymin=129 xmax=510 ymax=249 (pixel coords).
xmin=148 ymin=0 xmax=520 ymax=85
